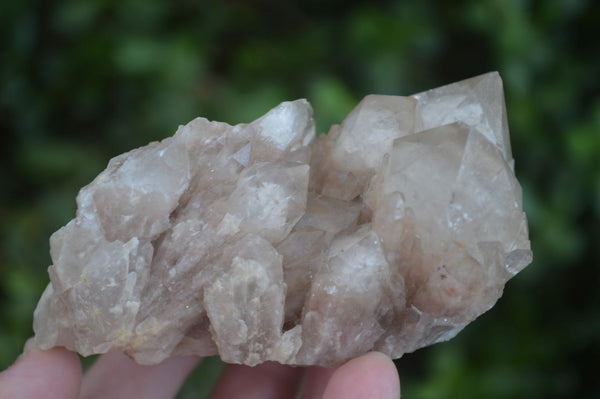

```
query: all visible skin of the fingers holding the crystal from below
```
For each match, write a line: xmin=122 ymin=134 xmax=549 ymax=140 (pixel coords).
xmin=0 ymin=348 xmax=400 ymax=399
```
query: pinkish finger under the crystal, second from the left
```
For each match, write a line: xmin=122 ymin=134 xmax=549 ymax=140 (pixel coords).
xmin=81 ymin=352 xmax=200 ymax=399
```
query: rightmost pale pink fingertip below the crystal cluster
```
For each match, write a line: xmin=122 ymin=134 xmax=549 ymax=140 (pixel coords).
xmin=323 ymin=352 xmax=400 ymax=399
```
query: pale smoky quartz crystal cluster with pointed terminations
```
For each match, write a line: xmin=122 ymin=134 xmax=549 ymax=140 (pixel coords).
xmin=34 ymin=73 xmax=531 ymax=366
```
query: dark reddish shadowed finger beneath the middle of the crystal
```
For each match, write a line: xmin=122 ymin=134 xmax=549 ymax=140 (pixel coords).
xmin=211 ymin=362 xmax=303 ymax=399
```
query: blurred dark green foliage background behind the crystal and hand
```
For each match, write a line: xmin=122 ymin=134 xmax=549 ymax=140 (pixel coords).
xmin=0 ymin=0 xmax=600 ymax=399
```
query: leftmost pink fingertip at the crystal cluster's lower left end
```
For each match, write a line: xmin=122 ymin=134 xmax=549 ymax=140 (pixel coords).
xmin=0 ymin=348 xmax=81 ymax=399
